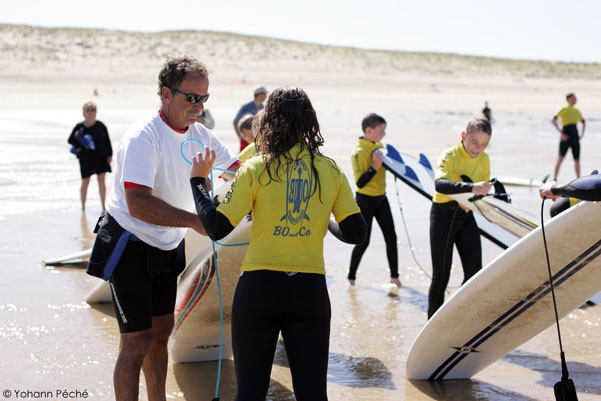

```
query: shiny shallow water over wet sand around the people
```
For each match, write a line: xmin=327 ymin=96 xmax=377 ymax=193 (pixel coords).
xmin=0 ymin=108 xmax=601 ymax=400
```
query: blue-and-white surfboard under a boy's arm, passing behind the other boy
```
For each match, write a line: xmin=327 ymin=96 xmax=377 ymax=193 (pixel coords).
xmin=383 ymin=144 xmax=518 ymax=249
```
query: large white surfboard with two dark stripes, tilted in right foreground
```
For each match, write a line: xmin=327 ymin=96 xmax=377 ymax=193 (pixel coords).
xmin=406 ymin=202 xmax=601 ymax=380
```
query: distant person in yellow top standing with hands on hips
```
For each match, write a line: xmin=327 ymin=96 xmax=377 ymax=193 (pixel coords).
xmin=551 ymin=93 xmax=585 ymax=181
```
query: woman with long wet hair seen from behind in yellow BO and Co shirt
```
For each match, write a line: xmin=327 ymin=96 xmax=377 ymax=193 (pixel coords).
xmin=190 ymin=87 xmax=366 ymax=401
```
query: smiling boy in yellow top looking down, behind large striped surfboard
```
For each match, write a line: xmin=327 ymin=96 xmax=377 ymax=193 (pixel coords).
xmin=428 ymin=118 xmax=492 ymax=319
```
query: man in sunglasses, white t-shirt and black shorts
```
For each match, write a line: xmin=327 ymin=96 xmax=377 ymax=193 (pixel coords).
xmin=99 ymin=57 xmax=240 ymax=400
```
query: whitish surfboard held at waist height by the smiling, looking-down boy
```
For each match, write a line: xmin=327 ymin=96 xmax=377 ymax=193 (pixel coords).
xmin=449 ymin=192 xmax=540 ymax=238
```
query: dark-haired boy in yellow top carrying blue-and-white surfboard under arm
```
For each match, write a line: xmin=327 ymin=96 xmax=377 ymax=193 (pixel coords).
xmin=347 ymin=113 xmax=401 ymax=287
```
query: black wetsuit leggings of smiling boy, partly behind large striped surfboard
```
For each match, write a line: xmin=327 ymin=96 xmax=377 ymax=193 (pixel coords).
xmin=428 ymin=202 xmax=482 ymax=319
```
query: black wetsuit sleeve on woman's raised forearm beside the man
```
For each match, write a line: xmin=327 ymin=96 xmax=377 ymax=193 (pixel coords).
xmin=190 ymin=177 xmax=234 ymax=241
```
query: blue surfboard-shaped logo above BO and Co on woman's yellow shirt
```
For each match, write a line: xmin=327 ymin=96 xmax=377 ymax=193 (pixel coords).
xmin=280 ymin=159 xmax=313 ymax=225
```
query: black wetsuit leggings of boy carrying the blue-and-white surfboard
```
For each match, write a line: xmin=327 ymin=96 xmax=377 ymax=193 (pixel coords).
xmin=348 ymin=193 xmax=399 ymax=280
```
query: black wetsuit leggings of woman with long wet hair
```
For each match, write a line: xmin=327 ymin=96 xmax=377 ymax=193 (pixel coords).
xmin=232 ymin=270 xmax=331 ymax=401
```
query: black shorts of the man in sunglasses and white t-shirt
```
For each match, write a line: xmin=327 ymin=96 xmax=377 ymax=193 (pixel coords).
xmin=109 ymin=241 xmax=186 ymax=333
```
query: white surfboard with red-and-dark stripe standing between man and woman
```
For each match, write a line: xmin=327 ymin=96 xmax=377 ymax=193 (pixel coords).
xmin=170 ymin=219 xmax=252 ymax=362
